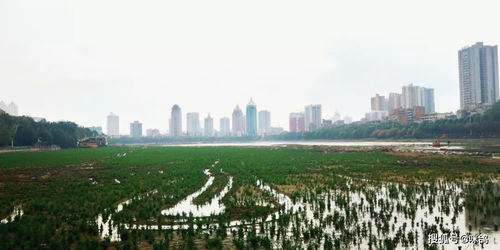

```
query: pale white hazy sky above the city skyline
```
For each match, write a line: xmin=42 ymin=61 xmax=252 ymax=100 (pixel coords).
xmin=0 ymin=0 xmax=500 ymax=134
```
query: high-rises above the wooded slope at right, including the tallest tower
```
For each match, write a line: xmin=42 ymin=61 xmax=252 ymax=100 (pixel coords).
xmin=363 ymin=42 xmax=499 ymax=124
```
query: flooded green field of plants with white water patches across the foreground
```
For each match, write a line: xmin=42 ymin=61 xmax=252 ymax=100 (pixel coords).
xmin=0 ymin=147 xmax=500 ymax=249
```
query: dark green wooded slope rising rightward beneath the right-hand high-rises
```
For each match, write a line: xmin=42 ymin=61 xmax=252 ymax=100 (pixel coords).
xmin=273 ymin=101 xmax=500 ymax=140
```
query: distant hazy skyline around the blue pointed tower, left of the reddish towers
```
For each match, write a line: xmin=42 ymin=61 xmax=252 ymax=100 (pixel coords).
xmin=107 ymin=99 xmax=283 ymax=137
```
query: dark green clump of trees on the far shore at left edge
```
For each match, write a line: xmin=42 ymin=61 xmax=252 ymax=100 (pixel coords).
xmin=0 ymin=110 xmax=96 ymax=148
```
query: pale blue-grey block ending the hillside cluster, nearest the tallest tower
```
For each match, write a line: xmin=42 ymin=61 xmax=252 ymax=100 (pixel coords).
xmin=401 ymin=84 xmax=435 ymax=113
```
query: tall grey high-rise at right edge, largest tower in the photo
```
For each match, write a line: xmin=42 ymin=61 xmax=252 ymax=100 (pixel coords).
xmin=458 ymin=42 xmax=499 ymax=109
